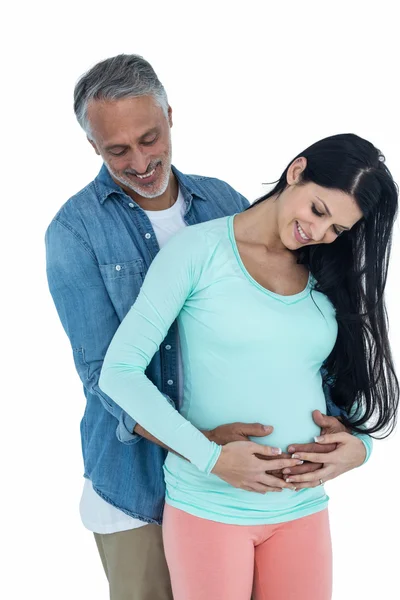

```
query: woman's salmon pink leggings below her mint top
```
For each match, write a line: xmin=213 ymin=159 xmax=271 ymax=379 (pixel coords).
xmin=163 ymin=505 xmax=332 ymax=600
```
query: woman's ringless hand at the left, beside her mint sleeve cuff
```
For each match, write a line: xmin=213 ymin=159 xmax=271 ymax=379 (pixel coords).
xmin=212 ymin=442 xmax=300 ymax=494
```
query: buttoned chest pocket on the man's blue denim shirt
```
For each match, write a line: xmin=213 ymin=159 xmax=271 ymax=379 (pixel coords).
xmin=100 ymin=258 xmax=144 ymax=321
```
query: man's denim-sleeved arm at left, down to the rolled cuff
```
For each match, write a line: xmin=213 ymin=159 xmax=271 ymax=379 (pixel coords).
xmin=46 ymin=220 xmax=141 ymax=444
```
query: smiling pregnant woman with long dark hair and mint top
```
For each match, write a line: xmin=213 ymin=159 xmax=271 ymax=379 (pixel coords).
xmin=100 ymin=134 xmax=398 ymax=600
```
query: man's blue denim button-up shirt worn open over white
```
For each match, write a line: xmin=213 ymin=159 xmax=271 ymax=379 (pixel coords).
xmin=46 ymin=165 xmax=253 ymax=523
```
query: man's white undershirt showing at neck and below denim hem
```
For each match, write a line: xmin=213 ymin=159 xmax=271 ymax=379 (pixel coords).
xmin=79 ymin=190 xmax=186 ymax=533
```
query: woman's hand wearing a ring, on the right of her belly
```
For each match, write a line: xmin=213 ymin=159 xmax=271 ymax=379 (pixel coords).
xmin=286 ymin=432 xmax=366 ymax=490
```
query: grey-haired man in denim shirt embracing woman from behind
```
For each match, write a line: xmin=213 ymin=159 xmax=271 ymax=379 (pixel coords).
xmin=46 ymin=55 xmax=346 ymax=600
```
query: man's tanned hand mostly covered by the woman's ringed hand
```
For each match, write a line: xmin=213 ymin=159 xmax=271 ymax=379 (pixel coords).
xmin=283 ymin=410 xmax=349 ymax=477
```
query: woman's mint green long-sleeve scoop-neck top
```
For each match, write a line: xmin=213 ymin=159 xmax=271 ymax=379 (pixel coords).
xmin=100 ymin=217 xmax=370 ymax=525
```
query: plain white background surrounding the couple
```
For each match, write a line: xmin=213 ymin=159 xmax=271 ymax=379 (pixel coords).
xmin=0 ymin=0 xmax=400 ymax=600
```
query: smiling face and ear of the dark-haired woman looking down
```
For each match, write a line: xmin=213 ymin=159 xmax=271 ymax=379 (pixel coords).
xmin=277 ymin=158 xmax=363 ymax=250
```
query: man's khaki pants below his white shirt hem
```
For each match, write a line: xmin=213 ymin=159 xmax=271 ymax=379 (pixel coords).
xmin=94 ymin=524 xmax=173 ymax=600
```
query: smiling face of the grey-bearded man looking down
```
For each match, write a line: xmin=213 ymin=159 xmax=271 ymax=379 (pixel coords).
xmin=87 ymin=96 xmax=172 ymax=198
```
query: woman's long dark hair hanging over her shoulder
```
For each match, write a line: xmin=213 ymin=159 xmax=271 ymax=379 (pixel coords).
xmin=250 ymin=134 xmax=399 ymax=437
